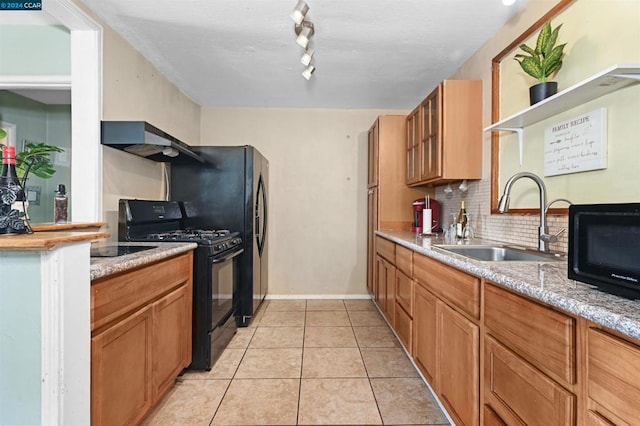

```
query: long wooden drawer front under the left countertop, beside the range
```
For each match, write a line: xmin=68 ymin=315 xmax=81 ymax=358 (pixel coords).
xmin=91 ymin=252 xmax=193 ymax=332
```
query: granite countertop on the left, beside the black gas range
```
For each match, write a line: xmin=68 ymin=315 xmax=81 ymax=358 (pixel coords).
xmin=91 ymin=242 xmax=198 ymax=281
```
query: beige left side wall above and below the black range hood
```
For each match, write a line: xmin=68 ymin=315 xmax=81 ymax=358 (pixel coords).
xmin=74 ymin=0 xmax=200 ymax=236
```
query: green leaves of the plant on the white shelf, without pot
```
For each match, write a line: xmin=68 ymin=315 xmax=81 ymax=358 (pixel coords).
xmin=514 ymin=21 xmax=567 ymax=83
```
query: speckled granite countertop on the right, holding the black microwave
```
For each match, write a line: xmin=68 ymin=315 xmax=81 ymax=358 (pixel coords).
xmin=376 ymin=231 xmax=640 ymax=340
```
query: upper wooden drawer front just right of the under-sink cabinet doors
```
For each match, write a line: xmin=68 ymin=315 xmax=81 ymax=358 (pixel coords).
xmin=484 ymin=284 xmax=576 ymax=384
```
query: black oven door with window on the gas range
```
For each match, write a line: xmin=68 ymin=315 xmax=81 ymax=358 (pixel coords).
xmin=209 ymin=248 xmax=244 ymax=330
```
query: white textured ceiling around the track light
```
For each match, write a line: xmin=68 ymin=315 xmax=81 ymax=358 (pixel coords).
xmin=77 ymin=0 xmax=525 ymax=109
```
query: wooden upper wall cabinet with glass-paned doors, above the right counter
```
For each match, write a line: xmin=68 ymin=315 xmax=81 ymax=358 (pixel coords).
xmin=407 ymin=80 xmax=482 ymax=185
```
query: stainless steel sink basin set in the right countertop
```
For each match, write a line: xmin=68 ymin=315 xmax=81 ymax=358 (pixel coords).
xmin=434 ymin=245 xmax=563 ymax=262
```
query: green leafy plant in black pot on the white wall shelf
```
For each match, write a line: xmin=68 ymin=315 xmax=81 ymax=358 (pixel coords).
xmin=514 ymin=21 xmax=567 ymax=105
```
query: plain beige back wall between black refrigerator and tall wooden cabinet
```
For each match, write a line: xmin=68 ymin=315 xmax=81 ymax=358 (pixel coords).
xmin=201 ymin=108 xmax=408 ymax=296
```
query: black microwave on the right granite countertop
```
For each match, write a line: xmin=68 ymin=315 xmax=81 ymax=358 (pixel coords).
xmin=568 ymin=203 xmax=640 ymax=299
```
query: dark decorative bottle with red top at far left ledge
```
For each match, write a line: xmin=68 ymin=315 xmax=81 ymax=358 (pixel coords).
xmin=0 ymin=145 xmax=29 ymax=234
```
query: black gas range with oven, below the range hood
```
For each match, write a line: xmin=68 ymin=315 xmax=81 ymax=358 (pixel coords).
xmin=118 ymin=200 xmax=243 ymax=370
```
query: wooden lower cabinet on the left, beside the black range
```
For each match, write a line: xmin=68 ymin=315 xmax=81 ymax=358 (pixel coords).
xmin=91 ymin=252 xmax=193 ymax=426
